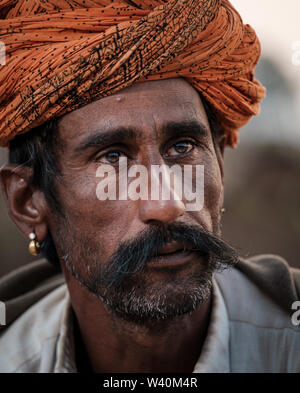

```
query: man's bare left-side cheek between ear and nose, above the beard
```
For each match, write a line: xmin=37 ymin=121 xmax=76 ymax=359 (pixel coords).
xmin=54 ymin=171 xmax=136 ymax=259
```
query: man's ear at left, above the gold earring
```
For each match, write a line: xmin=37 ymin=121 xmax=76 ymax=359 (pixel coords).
xmin=0 ymin=165 xmax=48 ymax=242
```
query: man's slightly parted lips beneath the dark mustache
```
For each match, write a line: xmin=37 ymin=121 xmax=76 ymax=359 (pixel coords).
xmin=147 ymin=241 xmax=195 ymax=267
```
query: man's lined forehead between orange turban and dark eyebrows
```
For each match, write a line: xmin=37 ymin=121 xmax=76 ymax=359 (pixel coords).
xmin=59 ymin=78 xmax=209 ymax=146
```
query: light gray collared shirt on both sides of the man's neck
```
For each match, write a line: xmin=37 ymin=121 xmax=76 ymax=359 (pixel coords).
xmin=0 ymin=258 xmax=300 ymax=373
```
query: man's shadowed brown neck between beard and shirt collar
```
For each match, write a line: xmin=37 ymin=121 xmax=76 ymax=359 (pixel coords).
xmin=65 ymin=264 xmax=211 ymax=373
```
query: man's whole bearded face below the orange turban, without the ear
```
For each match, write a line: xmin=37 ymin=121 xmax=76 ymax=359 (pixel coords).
xmin=49 ymin=79 xmax=234 ymax=320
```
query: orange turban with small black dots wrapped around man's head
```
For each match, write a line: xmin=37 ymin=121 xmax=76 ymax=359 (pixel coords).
xmin=0 ymin=0 xmax=265 ymax=146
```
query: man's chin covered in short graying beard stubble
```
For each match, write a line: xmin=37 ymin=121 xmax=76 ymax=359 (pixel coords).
xmin=98 ymin=274 xmax=212 ymax=325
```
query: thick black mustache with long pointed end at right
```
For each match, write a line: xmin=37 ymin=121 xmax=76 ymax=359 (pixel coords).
xmin=100 ymin=223 xmax=239 ymax=287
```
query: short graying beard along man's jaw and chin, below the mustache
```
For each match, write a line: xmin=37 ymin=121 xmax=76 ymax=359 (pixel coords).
xmin=57 ymin=219 xmax=236 ymax=325
